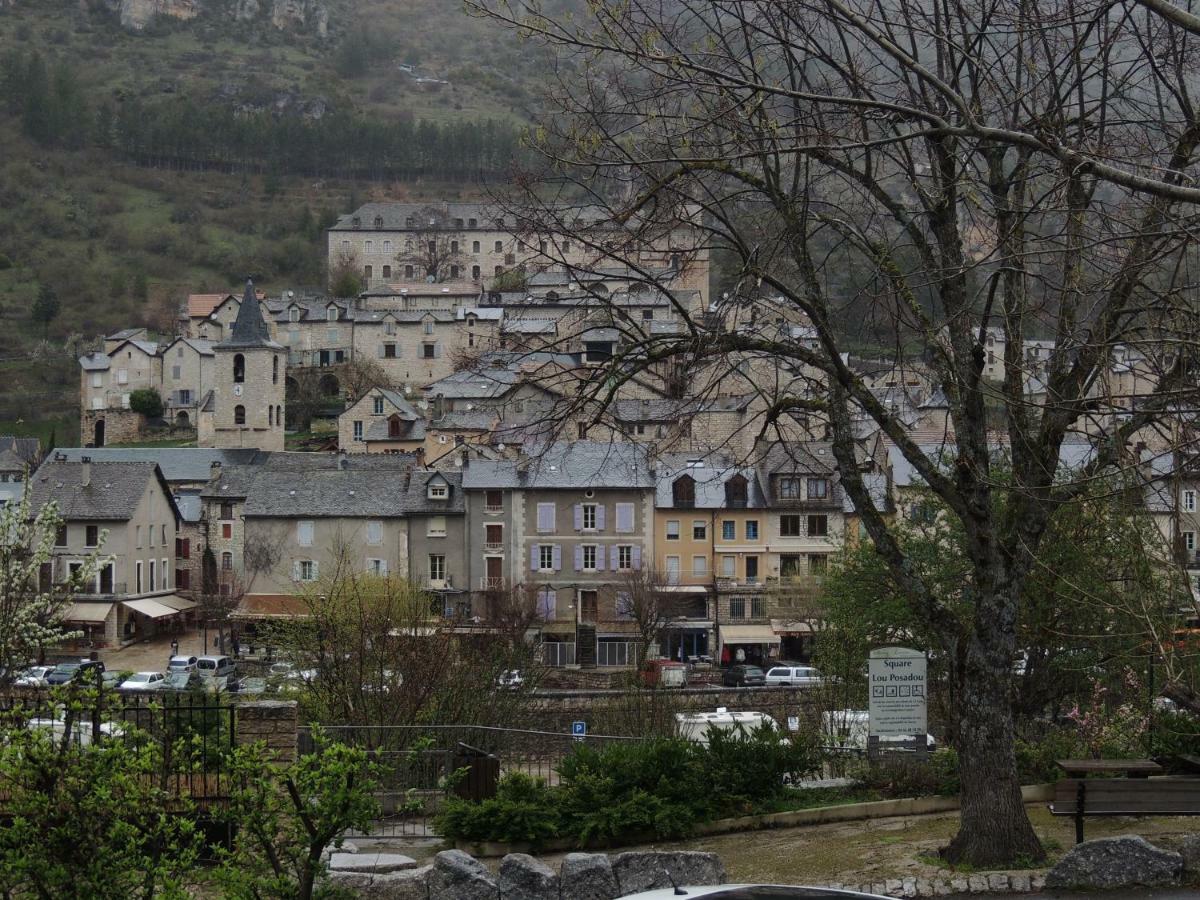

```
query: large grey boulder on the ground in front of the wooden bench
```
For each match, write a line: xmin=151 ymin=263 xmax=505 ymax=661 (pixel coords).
xmin=1046 ymin=834 xmax=1183 ymax=890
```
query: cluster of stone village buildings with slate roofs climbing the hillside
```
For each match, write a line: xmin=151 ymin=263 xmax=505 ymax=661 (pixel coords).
xmin=9 ymin=203 xmax=1200 ymax=668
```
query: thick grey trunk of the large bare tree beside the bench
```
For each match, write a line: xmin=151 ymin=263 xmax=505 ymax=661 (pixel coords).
xmin=942 ymin=589 xmax=1045 ymax=868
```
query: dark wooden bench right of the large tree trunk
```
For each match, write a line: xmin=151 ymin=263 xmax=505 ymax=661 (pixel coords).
xmin=1050 ymin=778 xmax=1200 ymax=844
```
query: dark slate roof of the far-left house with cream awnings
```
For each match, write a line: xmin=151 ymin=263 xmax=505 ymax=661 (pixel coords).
xmin=29 ymin=458 xmax=178 ymax=522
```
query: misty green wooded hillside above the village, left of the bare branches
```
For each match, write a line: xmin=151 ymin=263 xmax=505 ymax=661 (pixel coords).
xmin=0 ymin=0 xmax=564 ymax=436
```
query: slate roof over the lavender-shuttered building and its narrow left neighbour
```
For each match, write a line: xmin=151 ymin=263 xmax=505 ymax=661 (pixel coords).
xmin=462 ymin=440 xmax=655 ymax=491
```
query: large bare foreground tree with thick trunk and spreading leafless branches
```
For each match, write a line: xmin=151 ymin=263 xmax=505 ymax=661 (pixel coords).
xmin=468 ymin=0 xmax=1200 ymax=865
